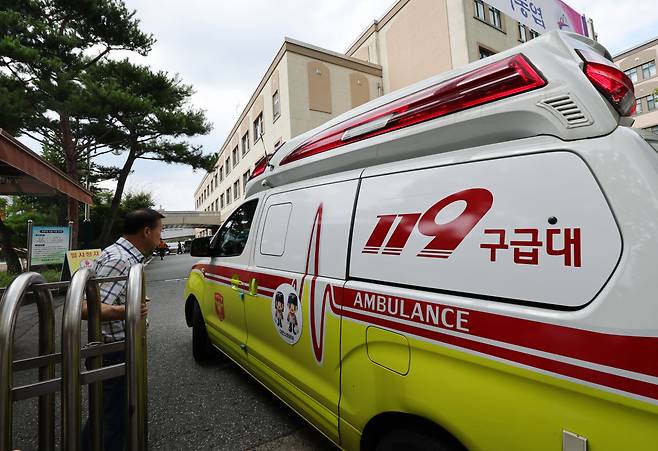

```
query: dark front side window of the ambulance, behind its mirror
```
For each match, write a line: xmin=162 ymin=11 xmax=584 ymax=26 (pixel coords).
xmin=210 ymin=199 xmax=258 ymax=257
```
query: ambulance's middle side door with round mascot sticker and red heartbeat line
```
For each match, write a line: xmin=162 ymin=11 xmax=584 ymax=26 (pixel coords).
xmin=245 ymin=172 xmax=360 ymax=443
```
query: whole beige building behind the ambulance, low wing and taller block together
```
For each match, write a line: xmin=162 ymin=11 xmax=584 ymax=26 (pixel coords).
xmin=194 ymin=0 xmax=560 ymax=226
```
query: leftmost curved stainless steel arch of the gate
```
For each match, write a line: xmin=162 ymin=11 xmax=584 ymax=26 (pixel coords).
xmin=0 ymin=272 xmax=55 ymax=451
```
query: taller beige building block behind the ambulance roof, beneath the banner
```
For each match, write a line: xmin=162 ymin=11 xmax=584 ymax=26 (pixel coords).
xmin=345 ymin=0 xmax=537 ymax=92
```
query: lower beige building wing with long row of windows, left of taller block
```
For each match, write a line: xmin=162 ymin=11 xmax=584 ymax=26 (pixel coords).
xmin=194 ymin=38 xmax=382 ymax=233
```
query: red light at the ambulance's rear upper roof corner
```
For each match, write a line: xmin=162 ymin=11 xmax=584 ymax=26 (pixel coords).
xmin=578 ymin=50 xmax=636 ymax=116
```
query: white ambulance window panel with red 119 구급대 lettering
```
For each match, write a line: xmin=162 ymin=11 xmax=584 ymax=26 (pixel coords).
xmin=350 ymin=152 xmax=621 ymax=308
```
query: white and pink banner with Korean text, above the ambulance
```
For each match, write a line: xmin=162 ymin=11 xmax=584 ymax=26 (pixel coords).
xmin=487 ymin=0 xmax=587 ymax=36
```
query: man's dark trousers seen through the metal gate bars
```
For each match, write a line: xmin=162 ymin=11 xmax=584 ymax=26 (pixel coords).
xmin=82 ymin=351 xmax=127 ymax=451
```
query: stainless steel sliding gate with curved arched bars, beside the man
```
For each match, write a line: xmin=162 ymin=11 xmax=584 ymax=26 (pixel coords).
xmin=0 ymin=265 xmax=148 ymax=451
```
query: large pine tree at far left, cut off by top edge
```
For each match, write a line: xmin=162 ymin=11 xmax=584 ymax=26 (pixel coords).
xmin=0 ymin=0 xmax=154 ymax=245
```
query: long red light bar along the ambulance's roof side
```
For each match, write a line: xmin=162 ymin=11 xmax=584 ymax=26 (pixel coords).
xmin=280 ymin=54 xmax=546 ymax=165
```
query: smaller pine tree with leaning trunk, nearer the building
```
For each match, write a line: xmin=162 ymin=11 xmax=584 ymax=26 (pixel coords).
xmin=82 ymin=60 xmax=216 ymax=244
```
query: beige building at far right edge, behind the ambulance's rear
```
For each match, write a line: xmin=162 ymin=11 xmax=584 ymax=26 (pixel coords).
xmin=613 ymin=37 xmax=658 ymax=133
